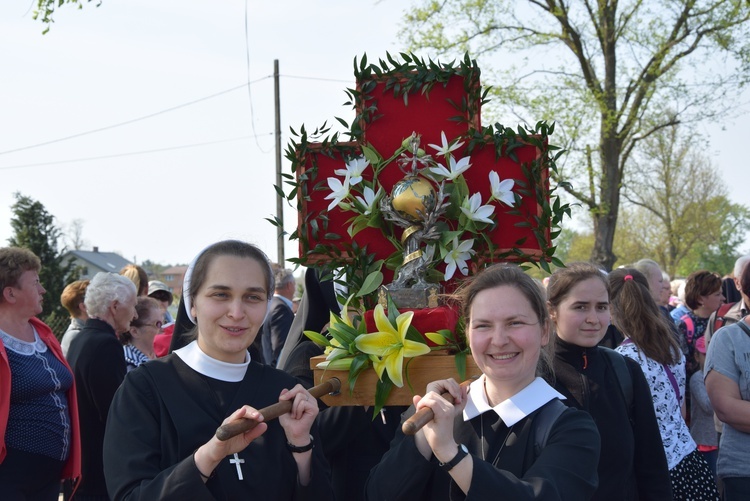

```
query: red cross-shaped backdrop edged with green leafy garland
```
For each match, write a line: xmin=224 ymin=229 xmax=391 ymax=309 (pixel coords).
xmin=288 ymin=55 xmax=551 ymax=283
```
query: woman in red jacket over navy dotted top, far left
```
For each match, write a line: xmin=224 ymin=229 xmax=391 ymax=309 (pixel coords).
xmin=0 ymin=247 xmax=81 ymax=501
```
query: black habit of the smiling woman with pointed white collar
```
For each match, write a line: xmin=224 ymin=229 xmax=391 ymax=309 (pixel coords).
xmin=366 ymin=401 xmax=599 ymax=501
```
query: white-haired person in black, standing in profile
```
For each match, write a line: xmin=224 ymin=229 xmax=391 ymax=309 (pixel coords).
xmin=68 ymin=273 xmax=138 ymax=501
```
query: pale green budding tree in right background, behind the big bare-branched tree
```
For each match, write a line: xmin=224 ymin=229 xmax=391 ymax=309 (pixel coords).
xmin=615 ymin=126 xmax=750 ymax=276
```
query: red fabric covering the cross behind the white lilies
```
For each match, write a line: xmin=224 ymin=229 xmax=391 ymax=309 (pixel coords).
xmin=298 ymin=72 xmax=550 ymax=274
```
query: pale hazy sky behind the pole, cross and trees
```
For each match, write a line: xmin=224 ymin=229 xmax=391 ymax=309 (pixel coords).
xmin=0 ymin=0 xmax=750 ymax=270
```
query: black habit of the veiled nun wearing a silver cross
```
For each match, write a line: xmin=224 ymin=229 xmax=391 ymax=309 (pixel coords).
xmin=104 ymin=354 xmax=332 ymax=501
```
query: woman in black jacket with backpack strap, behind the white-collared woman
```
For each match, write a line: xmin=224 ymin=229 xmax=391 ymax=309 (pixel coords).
xmin=547 ymin=263 xmax=672 ymax=500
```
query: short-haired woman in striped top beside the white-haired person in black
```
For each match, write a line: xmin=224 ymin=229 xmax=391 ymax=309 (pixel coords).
xmin=120 ymin=296 xmax=164 ymax=372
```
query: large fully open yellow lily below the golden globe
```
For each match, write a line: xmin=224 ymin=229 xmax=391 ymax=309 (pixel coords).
xmin=354 ymin=305 xmax=430 ymax=388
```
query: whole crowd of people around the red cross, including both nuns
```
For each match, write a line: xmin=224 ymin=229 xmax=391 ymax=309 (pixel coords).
xmin=0 ymin=240 xmax=750 ymax=501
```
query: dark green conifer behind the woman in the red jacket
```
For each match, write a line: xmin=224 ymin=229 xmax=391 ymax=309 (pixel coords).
xmin=8 ymin=193 xmax=73 ymax=319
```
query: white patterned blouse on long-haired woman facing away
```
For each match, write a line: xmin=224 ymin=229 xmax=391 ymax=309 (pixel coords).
xmin=617 ymin=343 xmax=697 ymax=470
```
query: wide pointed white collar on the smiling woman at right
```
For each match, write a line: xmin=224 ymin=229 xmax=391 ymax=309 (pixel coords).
xmin=464 ymin=374 xmax=565 ymax=426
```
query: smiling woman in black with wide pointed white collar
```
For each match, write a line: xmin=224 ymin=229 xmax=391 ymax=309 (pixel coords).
xmin=366 ymin=265 xmax=599 ymax=500
